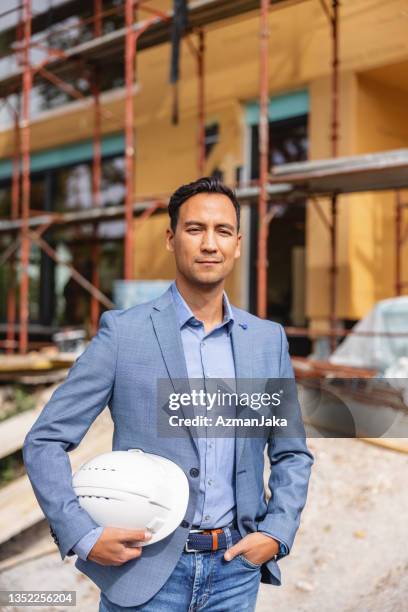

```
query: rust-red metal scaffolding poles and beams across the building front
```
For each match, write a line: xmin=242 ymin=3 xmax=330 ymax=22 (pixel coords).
xmin=0 ymin=0 xmax=408 ymax=354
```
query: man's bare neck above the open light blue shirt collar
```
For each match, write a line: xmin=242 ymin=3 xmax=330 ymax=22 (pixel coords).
xmin=176 ymin=277 xmax=224 ymax=333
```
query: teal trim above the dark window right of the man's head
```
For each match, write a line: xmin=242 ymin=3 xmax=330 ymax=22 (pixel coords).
xmin=245 ymin=89 xmax=309 ymax=126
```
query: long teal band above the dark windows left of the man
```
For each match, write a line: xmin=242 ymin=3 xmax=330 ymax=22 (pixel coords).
xmin=0 ymin=133 xmax=125 ymax=180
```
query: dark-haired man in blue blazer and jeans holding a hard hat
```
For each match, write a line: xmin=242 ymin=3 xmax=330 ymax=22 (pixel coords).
xmin=24 ymin=178 xmax=313 ymax=612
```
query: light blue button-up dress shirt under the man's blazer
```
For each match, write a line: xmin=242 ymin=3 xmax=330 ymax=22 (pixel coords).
xmin=73 ymin=281 xmax=286 ymax=560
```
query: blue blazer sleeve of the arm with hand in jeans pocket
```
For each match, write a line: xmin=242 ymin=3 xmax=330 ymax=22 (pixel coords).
xmin=258 ymin=325 xmax=314 ymax=551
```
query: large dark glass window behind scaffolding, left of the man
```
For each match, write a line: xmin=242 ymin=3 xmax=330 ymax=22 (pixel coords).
xmin=0 ymin=155 xmax=125 ymax=326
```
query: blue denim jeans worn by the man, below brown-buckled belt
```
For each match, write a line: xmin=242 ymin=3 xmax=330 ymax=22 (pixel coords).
xmin=99 ymin=550 xmax=261 ymax=612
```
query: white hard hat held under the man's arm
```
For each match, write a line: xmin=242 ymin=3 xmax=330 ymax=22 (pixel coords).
xmin=72 ymin=449 xmax=189 ymax=545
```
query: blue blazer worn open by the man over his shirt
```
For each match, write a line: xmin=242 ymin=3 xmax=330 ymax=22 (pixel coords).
xmin=23 ymin=289 xmax=313 ymax=606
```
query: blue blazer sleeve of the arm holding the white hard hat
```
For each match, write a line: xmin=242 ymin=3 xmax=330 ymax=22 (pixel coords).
xmin=23 ymin=311 xmax=118 ymax=559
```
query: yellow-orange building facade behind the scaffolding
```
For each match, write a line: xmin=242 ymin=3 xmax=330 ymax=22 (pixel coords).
xmin=0 ymin=0 xmax=408 ymax=327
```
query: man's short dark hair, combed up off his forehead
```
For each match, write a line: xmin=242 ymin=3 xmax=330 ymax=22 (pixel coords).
xmin=168 ymin=176 xmax=240 ymax=232
